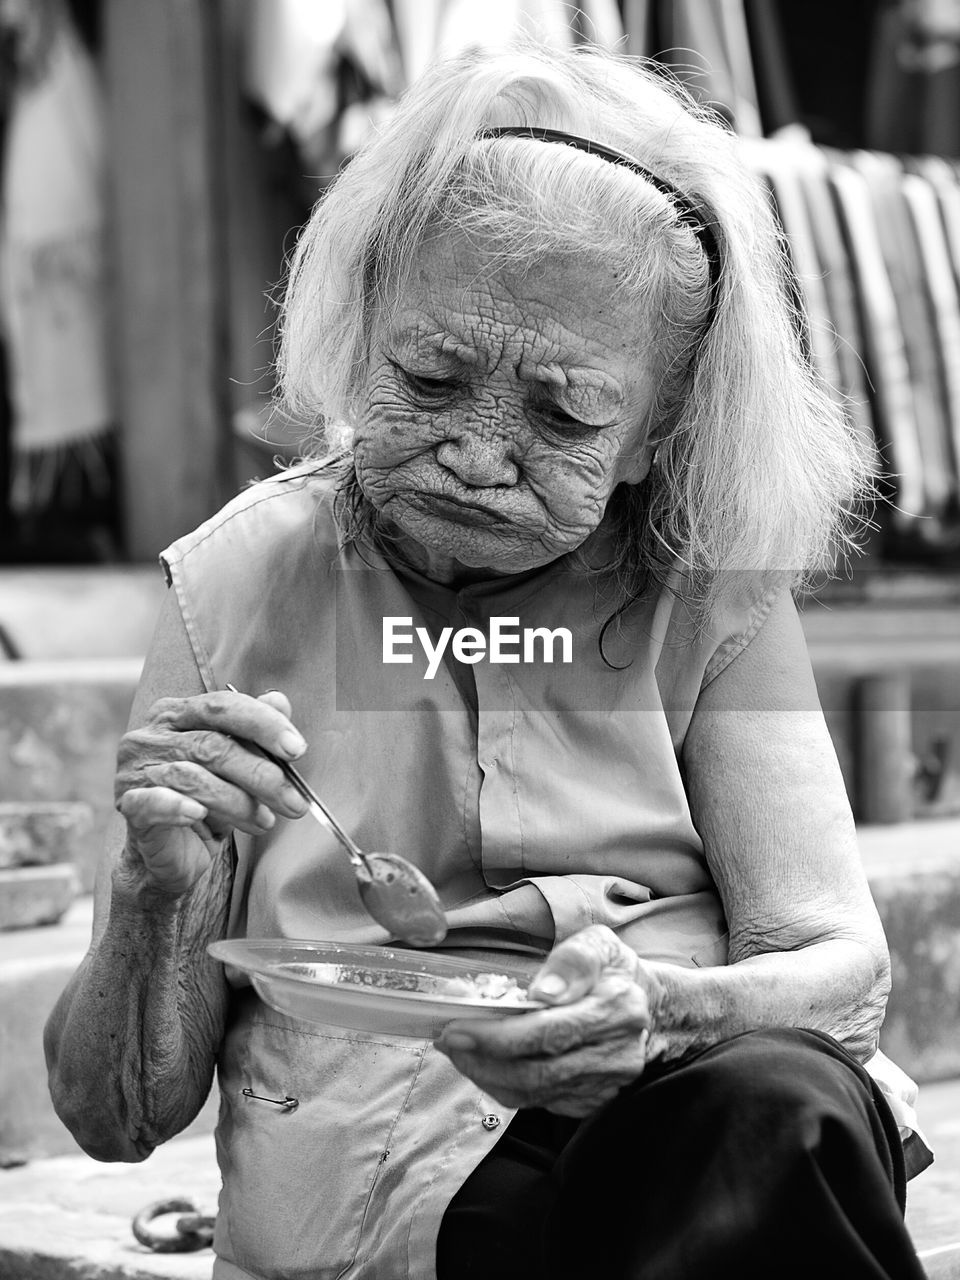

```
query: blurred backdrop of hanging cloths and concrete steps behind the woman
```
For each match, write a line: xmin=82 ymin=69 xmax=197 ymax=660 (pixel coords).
xmin=0 ymin=0 xmax=960 ymax=1269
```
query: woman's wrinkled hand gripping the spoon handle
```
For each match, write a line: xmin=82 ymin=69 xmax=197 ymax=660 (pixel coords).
xmin=114 ymin=690 xmax=306 ymax=896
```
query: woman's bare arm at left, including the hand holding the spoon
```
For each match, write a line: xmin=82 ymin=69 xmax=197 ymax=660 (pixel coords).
xmin=45 ymin=593 xmax=308 ymax=1161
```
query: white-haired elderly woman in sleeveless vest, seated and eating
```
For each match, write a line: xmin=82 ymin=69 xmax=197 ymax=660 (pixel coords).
xmin=47 ymin=40 xmax=922 ymax=1280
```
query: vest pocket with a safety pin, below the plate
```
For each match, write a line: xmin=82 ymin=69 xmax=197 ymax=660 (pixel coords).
xmin=214 ymin=1011 xmax=424 ymax=1280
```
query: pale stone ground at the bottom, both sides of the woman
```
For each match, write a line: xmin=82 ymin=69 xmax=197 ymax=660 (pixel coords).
xmin=0 ymin=1080 xmax=960 ymax=1280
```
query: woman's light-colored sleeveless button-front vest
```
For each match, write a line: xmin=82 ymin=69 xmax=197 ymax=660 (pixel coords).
xmin=163 ymin=470 xmax=783 ymax=1280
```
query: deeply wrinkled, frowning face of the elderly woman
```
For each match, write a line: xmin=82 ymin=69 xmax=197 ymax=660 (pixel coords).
xmin=355 ymin=237 xmax=654 ymax=582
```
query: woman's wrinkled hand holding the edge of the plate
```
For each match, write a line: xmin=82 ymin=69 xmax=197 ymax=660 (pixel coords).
xmin=436 ymin=925 xmax=660 ymax=1117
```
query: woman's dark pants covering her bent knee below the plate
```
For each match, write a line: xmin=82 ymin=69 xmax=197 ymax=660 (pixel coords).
xmin=436 ymin=1030 xmax=924 ymax=1280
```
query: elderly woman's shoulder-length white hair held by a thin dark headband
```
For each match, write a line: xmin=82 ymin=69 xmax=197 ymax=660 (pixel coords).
xmin=273 ymin=46 xmax=874 ymax=619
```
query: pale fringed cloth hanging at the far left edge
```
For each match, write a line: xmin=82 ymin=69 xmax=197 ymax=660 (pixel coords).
xmin=0 ymin=8 xmax=113 ymax=511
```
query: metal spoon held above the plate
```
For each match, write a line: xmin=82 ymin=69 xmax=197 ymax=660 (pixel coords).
xmin=227 ymin=685 xmax=447 ymax=947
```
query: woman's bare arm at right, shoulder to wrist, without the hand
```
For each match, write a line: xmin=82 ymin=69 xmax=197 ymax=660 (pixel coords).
xmin=650 ymin=586 xmax=890 ymax=1059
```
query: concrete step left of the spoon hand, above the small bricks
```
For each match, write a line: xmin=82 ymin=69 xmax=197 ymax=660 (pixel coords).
xmin=0 ymin=658 xmax=142 ymax=891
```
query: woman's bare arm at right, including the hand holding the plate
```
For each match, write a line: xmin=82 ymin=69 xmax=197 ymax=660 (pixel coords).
xmin=439 ymin=588 xmax=888 ymax=1115
